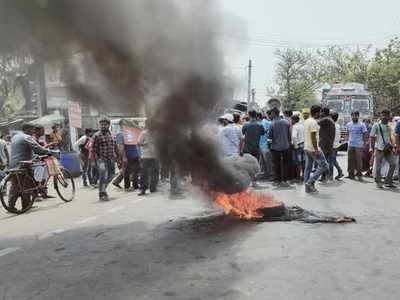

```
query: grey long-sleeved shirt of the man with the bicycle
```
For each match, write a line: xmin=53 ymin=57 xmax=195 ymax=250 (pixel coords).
xmin=10 ymin=132 xmax=51 ymax=168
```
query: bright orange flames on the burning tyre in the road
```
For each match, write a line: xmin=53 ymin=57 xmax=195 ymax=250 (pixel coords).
xmin=214 ymin=190 xmax=282 ymax=220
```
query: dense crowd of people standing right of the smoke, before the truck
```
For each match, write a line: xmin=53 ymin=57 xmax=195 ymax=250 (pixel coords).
xmin=219 ymin=105 xmax=400 ymax=193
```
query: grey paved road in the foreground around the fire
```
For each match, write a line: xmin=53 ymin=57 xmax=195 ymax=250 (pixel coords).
xmin=0 ymin=156 xmax=400 ymax=300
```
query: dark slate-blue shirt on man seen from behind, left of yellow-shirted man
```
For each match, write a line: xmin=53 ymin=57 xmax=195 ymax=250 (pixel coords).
xmin=268 ymin=118 xmax=292 ymax=151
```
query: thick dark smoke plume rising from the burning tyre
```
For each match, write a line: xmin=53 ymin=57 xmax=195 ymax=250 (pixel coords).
xmin=0 ymin=0 xmax=248 ymax=192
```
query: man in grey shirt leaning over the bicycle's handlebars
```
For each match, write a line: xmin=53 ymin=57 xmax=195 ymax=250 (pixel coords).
xmin=9 ymin=123 xmax=55 ymax=208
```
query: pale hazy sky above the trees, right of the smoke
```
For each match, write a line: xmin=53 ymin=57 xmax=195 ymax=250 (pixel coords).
xmin=218 ymin=0 xmax=400 ymax=104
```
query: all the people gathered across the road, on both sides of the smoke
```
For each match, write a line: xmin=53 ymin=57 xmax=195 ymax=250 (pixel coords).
xmin=0 ymin=105 xmax=400 ymax=211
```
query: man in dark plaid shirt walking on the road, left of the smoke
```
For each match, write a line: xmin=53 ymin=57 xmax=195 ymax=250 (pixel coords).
xmin=92 ymin=118 xmax=117 ymax=201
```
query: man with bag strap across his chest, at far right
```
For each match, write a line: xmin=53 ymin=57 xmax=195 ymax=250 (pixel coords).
xmin=370 ymin=109 xmax=396 ymax=188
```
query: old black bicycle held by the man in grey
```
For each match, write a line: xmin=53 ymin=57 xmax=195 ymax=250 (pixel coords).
xmin=0 ymin=155 xmax=75 ymax=214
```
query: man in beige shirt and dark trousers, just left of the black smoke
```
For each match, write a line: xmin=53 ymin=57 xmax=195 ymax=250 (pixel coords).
xmin=138 ymin=120 xmax=159 ymax=196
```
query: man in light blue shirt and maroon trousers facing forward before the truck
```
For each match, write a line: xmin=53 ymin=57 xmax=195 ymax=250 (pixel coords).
xmin=346 ymin=111 xmax=368 ymax=180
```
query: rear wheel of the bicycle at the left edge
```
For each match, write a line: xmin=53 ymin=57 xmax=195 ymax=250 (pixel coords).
xmin=0 ymin=173 xmax=37 ymax=215
